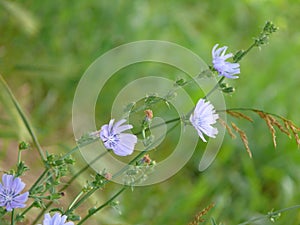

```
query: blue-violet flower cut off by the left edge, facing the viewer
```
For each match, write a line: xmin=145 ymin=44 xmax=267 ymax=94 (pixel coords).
xmin=0 ymin=174 xmax=29 ymax=211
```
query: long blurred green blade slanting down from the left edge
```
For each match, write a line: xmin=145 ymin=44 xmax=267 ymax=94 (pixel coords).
xmin=0 ymin=74 xmax=45 ymax=162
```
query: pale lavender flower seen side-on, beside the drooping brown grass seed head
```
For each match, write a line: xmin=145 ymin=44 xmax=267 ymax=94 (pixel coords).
xmin=190 ymin=99 xmax=219 ymax=142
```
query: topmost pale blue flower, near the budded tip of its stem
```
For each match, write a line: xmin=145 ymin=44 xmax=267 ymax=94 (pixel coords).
xmin=212 ymin=44 xmax=240 ymax=79
